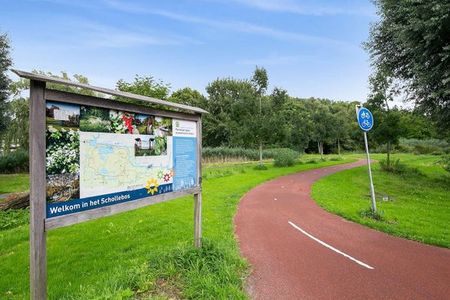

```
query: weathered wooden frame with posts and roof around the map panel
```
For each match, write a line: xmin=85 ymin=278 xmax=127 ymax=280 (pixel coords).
xmin=13 ymin=70 xmax=207 ymax=299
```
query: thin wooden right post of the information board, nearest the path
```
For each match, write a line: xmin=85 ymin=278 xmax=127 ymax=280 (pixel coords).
xmin=194 ymin=116 xmax=202 ymax=248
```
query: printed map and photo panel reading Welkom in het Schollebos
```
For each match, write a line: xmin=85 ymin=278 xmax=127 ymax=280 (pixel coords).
xmin=46 ymin=101 xmax=197 ymax=218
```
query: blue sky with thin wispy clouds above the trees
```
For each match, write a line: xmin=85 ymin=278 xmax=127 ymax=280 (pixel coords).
xmin=0 ymin=0 xmax=377 ymax=101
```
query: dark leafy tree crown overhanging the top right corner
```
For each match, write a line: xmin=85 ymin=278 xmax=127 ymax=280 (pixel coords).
xmin=365 ymin=0 xmax=450 ymax=130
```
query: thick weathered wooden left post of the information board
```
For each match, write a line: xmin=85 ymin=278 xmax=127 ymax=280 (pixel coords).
xmin=29 ymin=80 xmax=47 ymax=300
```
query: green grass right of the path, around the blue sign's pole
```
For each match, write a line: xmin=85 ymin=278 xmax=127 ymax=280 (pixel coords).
xmin=312 ymin=154 xmax=450 ymax=248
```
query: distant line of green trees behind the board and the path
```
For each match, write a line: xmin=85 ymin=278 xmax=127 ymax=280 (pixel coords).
xmin=1 ymin=68 xmax=448 ymax=159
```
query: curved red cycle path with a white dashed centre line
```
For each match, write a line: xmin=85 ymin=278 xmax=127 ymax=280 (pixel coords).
xmin=235 ymin=161 xmax=450 ymax=299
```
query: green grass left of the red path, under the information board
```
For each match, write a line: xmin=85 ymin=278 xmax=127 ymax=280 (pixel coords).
xmin=0 ymin=156 xmax=356 ymax=299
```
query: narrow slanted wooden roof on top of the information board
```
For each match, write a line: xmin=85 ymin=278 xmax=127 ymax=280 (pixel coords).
xmin=12 ymin=70 xmax=208 ymax=114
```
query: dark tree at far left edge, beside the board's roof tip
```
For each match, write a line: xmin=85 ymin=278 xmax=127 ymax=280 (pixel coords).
xmin=0 ymin=34 xmax=12 ymax=134
